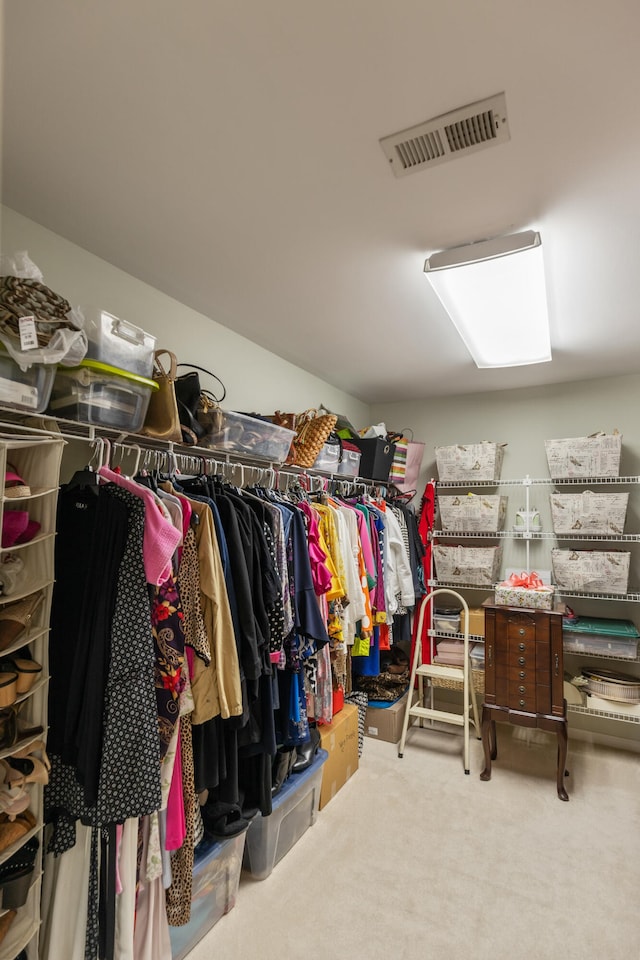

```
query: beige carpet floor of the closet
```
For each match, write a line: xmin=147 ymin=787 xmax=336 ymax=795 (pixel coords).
xmin=189 ymin=725 xmax=640 ymax=960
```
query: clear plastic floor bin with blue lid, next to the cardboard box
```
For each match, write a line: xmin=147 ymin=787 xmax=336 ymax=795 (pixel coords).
xmin=242 ymin=749 xmax=329 ymax=880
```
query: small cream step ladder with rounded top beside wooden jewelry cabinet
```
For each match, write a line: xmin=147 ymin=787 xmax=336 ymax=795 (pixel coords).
xmin=398 ymin=588 xmax=480 ymax=773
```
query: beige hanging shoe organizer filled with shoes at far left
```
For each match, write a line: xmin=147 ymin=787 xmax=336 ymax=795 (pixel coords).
xmin=0 ymin=436 xmax=64 ymax=960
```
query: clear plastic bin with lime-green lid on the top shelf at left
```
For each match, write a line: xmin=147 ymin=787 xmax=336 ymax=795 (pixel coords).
xmin=49 ymin=360 xmax=158 ymax=433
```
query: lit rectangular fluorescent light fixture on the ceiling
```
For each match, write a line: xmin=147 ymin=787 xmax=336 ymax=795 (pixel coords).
xmin=424 ymin=230 xmax=551 ymax=367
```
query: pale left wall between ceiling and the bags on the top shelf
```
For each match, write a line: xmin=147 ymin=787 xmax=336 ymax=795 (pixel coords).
xmin=2 ymin=207 xmax=369 ymax=427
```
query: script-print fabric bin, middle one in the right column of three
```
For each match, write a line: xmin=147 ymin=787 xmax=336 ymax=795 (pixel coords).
xmin=549 ymin=490 xmax=629 ymax=536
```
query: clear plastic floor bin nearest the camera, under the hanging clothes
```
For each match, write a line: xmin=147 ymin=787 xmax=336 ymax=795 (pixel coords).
xmin=169 ymin=830 xmax=247 ymax=960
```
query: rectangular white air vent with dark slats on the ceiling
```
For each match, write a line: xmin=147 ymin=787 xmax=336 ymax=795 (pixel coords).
xmin=380 ymin=93 xmax=509 ymax=177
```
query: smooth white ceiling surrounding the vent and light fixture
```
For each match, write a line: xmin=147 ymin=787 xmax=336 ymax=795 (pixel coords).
xmin=3 ymin=0 xmax=640 ymax=402
